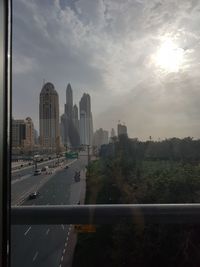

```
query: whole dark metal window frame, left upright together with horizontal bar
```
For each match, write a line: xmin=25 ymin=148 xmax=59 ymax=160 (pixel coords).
xmin=0 ymin=0 xmax=200 ymax=266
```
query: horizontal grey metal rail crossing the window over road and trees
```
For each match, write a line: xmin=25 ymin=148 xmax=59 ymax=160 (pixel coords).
xmin=11 ymin=204 xmax=200 ymax=225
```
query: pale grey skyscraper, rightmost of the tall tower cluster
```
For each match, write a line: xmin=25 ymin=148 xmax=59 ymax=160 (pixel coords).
xmin=79 ymin=93 xmax=93 ymax=145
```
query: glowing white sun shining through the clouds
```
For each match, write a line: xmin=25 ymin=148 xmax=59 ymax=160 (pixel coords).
xmin=153 ymin=39 xmax=184 ymax=72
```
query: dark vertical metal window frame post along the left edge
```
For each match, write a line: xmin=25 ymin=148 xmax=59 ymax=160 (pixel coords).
xmin=0 ymin=0 xmax=11 ymax=266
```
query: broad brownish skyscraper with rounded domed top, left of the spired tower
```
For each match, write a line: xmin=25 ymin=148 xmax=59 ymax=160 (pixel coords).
xmin=39 ymin=82 xmax=60 ymax=151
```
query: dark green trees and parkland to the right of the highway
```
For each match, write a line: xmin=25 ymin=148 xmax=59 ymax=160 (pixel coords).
xmin=73 ymin=135 xmax=200 ymax=267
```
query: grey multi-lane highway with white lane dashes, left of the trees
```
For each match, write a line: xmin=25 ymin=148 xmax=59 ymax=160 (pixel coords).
xmin=11 ymin=155 xmax=86 ymax=267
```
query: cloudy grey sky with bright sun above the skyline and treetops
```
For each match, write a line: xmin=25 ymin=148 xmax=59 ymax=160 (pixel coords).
xmin=13 ymin=0 xmax=200 ymax=140
